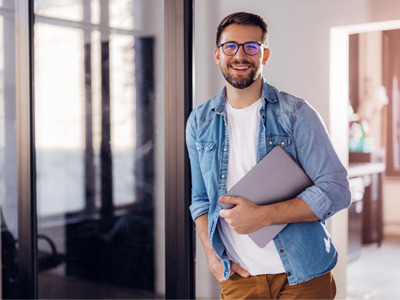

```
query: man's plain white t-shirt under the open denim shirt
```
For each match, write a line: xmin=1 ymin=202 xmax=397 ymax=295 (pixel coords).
xmin=218 ymin=99 xmax=285 ymax=275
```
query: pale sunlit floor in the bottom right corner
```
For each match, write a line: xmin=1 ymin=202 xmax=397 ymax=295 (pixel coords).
xmin=346 ymin=236 xmax=400 ymax=300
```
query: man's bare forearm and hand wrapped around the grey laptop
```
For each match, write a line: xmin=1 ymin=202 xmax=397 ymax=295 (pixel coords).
xmin=219 ymin=196 xmax=319 ymax=234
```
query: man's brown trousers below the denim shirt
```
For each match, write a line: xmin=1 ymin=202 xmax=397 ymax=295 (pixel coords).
xmin=220 ymin=271 xmax=336 ymax=299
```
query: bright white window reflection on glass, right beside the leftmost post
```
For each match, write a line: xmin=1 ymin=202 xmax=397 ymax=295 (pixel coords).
xmin=35 ymin=23 xmax=85 ymax=216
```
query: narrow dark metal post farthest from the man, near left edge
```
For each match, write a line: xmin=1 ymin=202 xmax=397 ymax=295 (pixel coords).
xmin=15 ymin=0 xmax=37 ymax=299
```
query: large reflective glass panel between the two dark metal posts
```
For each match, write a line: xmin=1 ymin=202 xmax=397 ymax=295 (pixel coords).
xmin=34 ymin=0 xmax=165 ymax=299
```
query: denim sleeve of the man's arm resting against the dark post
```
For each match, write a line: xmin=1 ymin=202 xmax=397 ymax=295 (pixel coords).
xmin=186 ymin=113 xmax=210 ymax=221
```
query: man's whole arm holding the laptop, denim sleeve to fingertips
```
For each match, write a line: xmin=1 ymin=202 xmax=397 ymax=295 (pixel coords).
xmin=220 ymin=102 xmax=351 ymax=234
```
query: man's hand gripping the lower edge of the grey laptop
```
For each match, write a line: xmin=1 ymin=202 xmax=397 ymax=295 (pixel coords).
xmin=219 ymin=196 xmax=267 ymax=234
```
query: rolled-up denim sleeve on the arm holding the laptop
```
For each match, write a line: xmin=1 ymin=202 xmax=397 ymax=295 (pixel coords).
xmin=293 ymin=101 xmax=351 ymax=221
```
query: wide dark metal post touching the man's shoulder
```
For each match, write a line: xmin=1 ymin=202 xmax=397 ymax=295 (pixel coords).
xmin=164 ymin=0 xmax=195 ymax=299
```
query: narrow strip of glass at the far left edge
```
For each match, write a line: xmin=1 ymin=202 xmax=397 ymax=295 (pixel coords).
xmin=0 ymin=0 xmax=18 ymax=299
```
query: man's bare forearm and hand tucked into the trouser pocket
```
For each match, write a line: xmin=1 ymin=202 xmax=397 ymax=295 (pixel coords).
xmin=195 ymin=214 xmax=250 ymax=282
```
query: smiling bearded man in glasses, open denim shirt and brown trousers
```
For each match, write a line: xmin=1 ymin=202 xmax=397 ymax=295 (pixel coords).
xmin=186 ymin=13 xmax=350 ymax=299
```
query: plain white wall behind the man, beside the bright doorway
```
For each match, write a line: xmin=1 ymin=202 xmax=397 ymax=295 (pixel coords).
xmin=195 ymin=0 xmax=400 ymax=298
